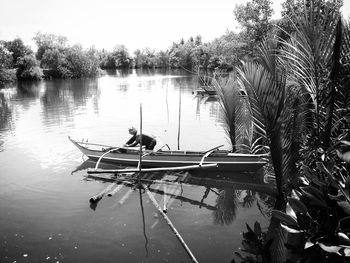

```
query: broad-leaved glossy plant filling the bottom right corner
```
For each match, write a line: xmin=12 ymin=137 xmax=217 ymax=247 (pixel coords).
xmin=273 ymin=141 xmax=350 ymax=262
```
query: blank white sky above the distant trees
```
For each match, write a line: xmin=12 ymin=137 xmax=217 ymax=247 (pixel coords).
xmin=0 ymin=0 xmax=350 ymax=52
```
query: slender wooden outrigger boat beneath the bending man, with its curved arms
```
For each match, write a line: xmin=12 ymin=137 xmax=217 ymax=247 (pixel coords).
xmin=68 ymin=137 xmax=268 ymax=173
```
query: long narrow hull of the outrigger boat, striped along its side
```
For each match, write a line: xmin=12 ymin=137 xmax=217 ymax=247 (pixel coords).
xmin=69 ymin=138 xmax=267 ymax=172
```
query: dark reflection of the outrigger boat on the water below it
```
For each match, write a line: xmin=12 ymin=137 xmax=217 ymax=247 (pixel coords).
xmin=72 ymin=160 xmax=276 ymax=212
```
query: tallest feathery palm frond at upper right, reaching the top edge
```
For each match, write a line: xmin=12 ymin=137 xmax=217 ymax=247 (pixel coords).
xmin=281 ymin=0 xmax=341 ymax=145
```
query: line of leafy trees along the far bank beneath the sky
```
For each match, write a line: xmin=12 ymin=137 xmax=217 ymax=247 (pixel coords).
xmin=0 ymin=0 xmax=286 ymax=83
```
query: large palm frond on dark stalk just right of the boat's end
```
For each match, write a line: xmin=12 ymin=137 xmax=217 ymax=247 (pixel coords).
xmin=238 ymin=41 xmax=289 ymax=194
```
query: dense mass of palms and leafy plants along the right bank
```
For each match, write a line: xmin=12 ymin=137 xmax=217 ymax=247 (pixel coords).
xmin=219 ymin=0 xmax=350 ymax=262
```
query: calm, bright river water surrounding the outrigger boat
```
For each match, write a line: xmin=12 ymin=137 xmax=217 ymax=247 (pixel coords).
xmin=0 ymin=71 xmax=271 ymax=263
